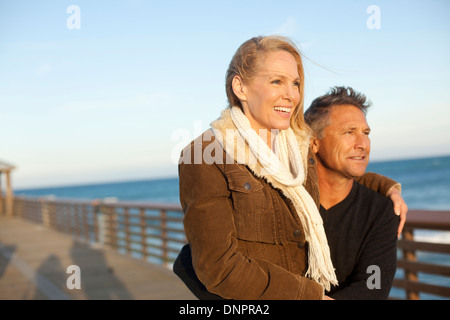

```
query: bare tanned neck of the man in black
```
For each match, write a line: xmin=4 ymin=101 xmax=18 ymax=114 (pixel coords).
xmin=317 ymin=165 xmax=353 ymax=210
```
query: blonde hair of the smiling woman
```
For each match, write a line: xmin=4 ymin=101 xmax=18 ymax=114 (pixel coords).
xmin=225 ymin=36 xmax=309 ymax=132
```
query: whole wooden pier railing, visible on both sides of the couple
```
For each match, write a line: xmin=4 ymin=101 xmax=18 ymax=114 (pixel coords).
xmin=6 ymin=197 xmax=450 ymax=300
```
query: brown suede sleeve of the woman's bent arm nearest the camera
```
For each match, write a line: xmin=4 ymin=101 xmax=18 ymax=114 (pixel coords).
xmin=179 ymin=141 xmax=323 ymax=300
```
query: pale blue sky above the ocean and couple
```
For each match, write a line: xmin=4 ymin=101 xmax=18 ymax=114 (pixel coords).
xmin=0 ymin=0 xmax=450 ymax=189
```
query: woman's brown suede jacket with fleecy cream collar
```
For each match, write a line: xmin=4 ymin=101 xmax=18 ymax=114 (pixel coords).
xmin=178 ymin=131 xmax=398 ymax=300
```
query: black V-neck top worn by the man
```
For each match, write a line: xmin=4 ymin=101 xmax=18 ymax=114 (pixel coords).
xmin=320 ymin=182 xmax=399 ymax=300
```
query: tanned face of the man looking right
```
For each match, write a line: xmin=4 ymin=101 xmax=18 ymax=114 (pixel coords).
xmin=313 ymin=105 xmax=370 ymax=179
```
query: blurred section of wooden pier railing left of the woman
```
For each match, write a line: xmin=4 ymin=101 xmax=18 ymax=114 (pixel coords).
xmin=14 ymin=197 xmax=187 ymax=266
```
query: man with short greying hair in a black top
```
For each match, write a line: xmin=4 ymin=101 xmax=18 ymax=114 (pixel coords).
xmin=305 ymin=87 xmax=399 ymax=299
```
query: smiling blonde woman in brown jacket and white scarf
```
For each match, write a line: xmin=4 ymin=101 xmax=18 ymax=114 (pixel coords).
xmin=174 ymin=37 xmax=404 ymax=299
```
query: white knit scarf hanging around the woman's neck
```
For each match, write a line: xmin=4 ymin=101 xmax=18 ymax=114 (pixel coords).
xmin=211 ymin=107 xmax=337 ymax=291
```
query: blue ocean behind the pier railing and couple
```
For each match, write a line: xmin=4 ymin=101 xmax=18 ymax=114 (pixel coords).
xmin=15 ymin=156 xmax=450 ymax=299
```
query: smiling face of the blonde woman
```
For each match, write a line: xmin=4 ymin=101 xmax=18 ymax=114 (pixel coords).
xmin=233 ymin=51 xmax=301 ymax=132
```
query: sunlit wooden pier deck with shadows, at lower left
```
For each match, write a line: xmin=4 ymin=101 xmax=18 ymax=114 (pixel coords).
xmin=0 ymin=216 xmax=195 ymax=300
